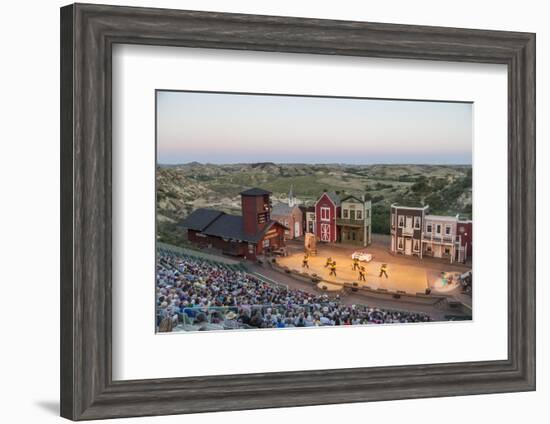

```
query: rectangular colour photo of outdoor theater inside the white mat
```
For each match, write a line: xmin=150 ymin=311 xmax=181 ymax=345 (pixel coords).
xmin=155 ymin=90 xmax=473 ymax=333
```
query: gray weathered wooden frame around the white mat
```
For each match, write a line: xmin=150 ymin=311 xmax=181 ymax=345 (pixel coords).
xmin=60 ymin=4 xmax=535 ymax=420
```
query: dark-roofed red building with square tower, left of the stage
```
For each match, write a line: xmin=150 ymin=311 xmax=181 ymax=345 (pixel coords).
xmin=179 ymin=188 xmax=287 ymax=260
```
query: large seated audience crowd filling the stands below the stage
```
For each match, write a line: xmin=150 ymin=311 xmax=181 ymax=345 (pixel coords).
xmin=156 ymin=251 xmax=436 ymax=332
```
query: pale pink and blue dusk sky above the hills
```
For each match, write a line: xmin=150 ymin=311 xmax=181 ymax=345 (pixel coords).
xmin=157 ymin=91 xmax=472 ymax=165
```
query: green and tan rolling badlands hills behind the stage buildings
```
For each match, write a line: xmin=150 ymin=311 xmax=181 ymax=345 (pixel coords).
xmin=157 ymin=162 xmax=472 ymax=244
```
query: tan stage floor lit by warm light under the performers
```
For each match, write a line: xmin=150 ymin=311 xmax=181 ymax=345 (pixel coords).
xmin=277 ymin=241 xmax=469 ymax=294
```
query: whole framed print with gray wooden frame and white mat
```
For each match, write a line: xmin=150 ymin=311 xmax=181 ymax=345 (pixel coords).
xmin=61 ymin=4 xmax=535 ymax=420
